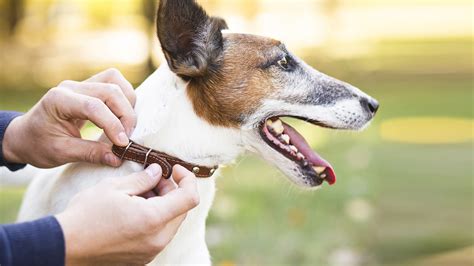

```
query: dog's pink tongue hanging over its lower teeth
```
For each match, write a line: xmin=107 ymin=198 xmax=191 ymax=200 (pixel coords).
xmin=283 ymin=122 xmax=336 ymax=185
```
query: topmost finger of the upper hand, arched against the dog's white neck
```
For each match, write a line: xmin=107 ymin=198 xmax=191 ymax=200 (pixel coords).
xmin=85 ymin=68 xmax=136 ymax=106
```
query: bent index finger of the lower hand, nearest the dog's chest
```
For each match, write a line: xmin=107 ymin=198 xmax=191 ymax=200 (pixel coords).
xmin=148 ymin=165 xmax=199 ymax=221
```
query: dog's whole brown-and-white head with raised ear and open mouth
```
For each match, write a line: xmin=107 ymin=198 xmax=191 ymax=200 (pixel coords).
xmin=157 ymin=0 xmax=378 ymax=187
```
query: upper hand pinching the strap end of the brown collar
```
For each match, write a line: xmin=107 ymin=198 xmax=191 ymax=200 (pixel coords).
xmin=3 ymin=69 xmax=136 ymax=168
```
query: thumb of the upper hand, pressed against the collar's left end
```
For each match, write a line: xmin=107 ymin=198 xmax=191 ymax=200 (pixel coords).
xmin=67 ymin=138 xmax=121 ymax=167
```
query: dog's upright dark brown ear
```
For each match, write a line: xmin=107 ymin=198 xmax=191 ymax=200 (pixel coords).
xmin=157 ymin=0 xmax=227 ymax=79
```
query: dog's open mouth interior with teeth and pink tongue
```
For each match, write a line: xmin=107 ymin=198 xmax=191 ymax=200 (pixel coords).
xmin=260 ymin=117 xmax=336 ymax=185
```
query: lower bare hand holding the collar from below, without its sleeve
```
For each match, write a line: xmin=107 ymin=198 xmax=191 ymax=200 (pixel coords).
xmin=56 ymin=164 xmax=199 ymax=265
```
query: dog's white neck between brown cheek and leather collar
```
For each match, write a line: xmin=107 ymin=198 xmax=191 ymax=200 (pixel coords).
xmin=132 ymin=64 xmax=244 ymax=166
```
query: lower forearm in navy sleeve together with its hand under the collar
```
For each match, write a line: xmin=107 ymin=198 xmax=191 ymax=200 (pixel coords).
xmin=0 ymin=165 xmax=199 ymax=266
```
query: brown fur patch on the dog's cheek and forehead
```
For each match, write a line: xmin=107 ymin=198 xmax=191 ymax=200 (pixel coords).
xmin=187 ymin=34 xmax=281 ymax=127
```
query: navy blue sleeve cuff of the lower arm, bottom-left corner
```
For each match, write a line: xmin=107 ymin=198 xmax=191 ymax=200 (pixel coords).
xmin=0 ymin=216 xmax=66 ymax=266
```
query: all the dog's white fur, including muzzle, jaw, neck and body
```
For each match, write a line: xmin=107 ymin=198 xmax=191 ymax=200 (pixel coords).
xmin=19 ymin=53 xmax=376 ymax=265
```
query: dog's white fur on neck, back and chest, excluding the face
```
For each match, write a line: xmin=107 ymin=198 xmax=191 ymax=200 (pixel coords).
xmin=19 ymin=64 xmax=243 ymax=265
